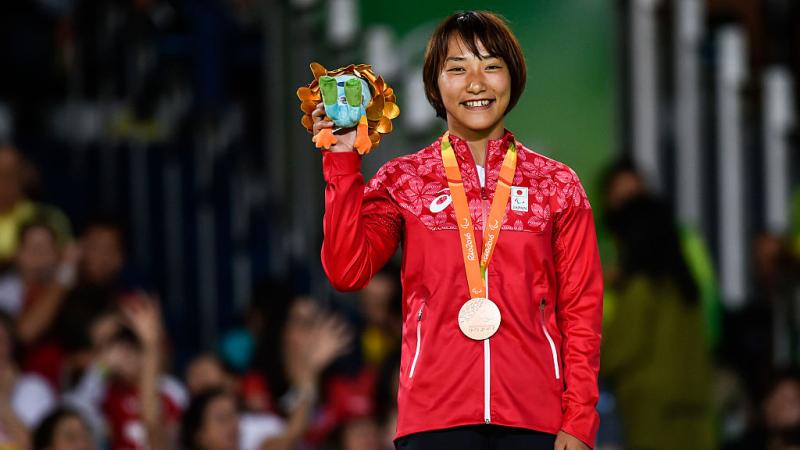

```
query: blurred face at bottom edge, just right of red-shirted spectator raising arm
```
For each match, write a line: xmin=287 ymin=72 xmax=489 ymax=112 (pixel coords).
xmin=197 ymin=395 xmax=239 ymax=450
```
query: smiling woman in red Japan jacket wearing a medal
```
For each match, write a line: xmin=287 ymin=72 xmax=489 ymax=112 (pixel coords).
xmin=313 ymin=12 xmax=602 ymax=450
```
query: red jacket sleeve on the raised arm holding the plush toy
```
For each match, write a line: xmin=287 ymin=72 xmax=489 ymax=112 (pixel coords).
xmin=321 ymin=151 xmax=402 ymax=291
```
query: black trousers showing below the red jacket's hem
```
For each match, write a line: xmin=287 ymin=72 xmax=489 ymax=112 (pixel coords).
xmin=395 ymin=425 xmax=556 ymax=450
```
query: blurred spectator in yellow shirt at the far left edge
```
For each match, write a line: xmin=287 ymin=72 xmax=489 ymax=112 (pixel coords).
xmin=0 ymin=145 xmax=72 ymax=265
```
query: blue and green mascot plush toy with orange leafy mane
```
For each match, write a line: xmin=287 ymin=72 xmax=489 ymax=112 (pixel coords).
xmin=297 ymin=63 xmax=400 ymax=155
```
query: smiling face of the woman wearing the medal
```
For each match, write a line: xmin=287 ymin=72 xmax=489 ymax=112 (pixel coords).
xmin=439 ymin=35 xmax=511 ymax=137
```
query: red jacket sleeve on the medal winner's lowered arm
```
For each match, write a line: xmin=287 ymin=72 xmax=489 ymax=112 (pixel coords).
xmin=553 ymin=172 xmax=603 ymax=448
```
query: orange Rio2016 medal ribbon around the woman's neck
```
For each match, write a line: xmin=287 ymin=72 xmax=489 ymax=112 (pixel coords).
xmin=441 ymin=132 xmax=517 ymax=298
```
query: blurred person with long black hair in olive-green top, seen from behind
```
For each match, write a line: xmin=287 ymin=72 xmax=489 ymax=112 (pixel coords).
xmin=601 ymin=197 xmax=716 ymax=450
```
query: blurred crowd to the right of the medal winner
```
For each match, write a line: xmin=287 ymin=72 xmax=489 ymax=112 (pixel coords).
xmin=598 ymin=160 xmax=800 ymax=450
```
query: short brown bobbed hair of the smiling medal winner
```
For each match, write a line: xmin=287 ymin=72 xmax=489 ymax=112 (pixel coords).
xmin=422 ymin=11 xmax=527 ymax=119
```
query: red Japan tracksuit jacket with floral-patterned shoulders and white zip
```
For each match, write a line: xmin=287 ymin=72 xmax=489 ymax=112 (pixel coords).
xmin=322 ymin=131 xmax=603 ymax=447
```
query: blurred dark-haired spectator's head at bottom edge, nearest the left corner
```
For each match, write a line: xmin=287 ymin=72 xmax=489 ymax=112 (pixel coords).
xmin=33 ymin=408 xmax=98 ymax=450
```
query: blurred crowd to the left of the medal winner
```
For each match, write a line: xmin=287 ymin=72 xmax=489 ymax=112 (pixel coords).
xmin=0 ymin=141 xmax=401 ymax=450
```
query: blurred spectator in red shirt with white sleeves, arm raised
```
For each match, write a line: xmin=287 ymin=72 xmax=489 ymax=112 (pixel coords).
xmin=65 ymin=295 xmax=184 ymax=450
